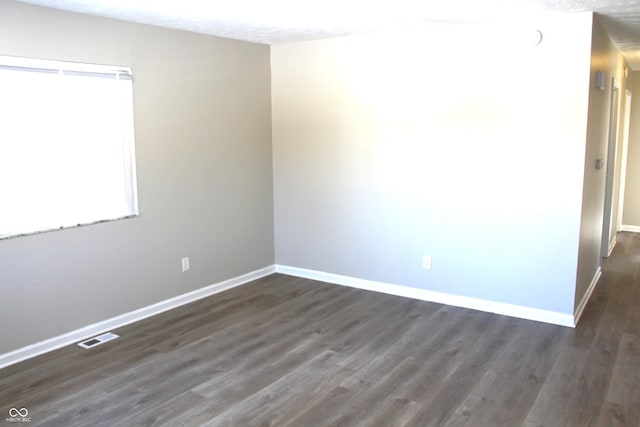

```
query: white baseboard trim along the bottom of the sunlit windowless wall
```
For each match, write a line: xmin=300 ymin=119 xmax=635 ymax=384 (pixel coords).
xmin=275 ymin=265 xmax=575 ymax=328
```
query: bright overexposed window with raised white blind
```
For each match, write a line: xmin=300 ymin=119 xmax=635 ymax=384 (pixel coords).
xmin=0 ymin=56 xmax=138 ymax=238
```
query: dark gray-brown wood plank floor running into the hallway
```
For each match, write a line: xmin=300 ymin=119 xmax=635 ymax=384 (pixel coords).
xmin=0 ymin=233 xmax=640 ymax=427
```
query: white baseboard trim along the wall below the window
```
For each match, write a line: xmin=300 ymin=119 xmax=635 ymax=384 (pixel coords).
xmin=0 ymin=265 xmax=275 ymax=369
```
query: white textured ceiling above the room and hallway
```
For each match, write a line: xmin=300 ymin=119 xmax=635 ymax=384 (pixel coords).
xmin=19 ymin=0 xmax=640 ymax=70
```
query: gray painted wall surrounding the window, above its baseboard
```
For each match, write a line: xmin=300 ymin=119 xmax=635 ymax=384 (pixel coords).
xmin=0 ymin=0 xmax=274 ymax=354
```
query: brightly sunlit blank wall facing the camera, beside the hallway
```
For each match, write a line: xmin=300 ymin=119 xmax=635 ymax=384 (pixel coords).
xmin=271 ymin=13 xmax=592 ymax=314
